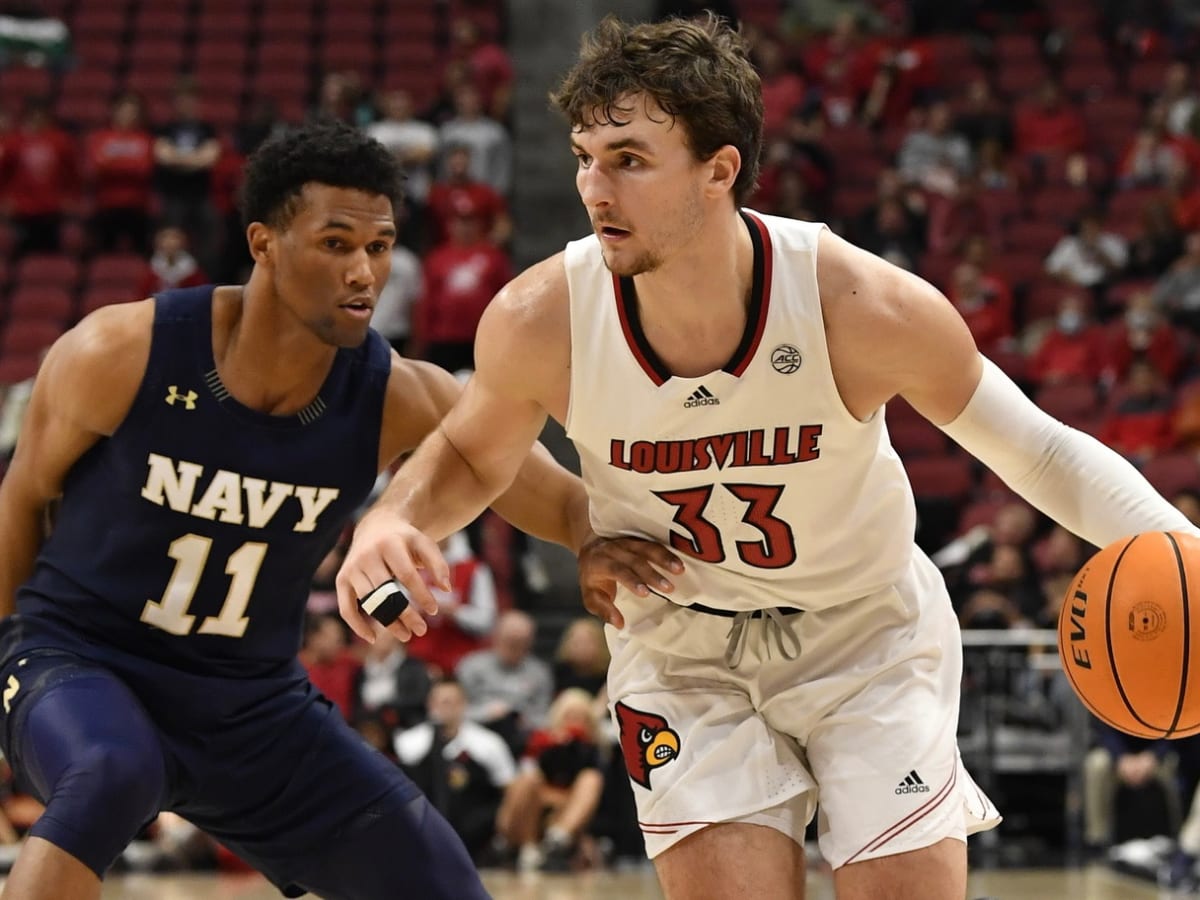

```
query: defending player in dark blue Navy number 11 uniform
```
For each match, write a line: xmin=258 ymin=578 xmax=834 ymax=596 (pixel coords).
xmin=0 ymin=125 xmax=672 ymax=900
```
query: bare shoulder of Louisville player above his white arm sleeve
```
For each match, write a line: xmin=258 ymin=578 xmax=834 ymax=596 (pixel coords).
xmin=817 ymin=230 xmax=978 ymax=421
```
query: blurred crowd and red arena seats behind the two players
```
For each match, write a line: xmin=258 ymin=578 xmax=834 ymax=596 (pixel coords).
xmin=0 ymin=0 xmax=1200 ymax=882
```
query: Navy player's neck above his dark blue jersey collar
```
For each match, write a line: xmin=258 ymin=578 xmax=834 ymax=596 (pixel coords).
xmin=212 ymin=283 xmax=337 ymax=415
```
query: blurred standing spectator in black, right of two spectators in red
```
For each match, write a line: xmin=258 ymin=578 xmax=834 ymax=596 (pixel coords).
xmin=154 ymin=84 xmax=221 ymax=273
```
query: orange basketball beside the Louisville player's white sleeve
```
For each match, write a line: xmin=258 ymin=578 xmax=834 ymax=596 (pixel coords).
xmin=1058 ymin=532 xmax=1200 ymax=738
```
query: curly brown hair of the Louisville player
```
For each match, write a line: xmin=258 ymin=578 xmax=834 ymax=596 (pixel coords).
xmin=550 ymin=13 xmax=762 ymax=205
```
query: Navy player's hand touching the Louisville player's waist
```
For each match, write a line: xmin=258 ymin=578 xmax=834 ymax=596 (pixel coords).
xmin=580 ymin=538 xmax=683 ymax=628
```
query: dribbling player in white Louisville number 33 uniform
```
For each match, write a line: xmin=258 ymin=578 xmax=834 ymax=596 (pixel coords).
xmin=338 ymin=19 xmax=1189 ymax=900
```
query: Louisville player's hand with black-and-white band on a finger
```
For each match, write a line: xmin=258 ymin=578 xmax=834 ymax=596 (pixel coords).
xmin=336 ymin=509 xmax=450 ymax=643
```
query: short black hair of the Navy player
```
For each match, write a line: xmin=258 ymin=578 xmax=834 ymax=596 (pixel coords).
xmin=241 ymin=119 xmax=404 ymax=228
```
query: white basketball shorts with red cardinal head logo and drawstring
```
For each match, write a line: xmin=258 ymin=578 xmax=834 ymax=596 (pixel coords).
xmin=606 ymin=551 xmax=1000 ymax=868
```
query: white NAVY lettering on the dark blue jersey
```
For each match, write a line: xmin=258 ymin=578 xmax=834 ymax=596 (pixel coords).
xmin=142 ymin=454 xmax=341 ymax=532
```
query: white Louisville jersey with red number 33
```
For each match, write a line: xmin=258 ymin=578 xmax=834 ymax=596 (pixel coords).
xmin=565 ymin=211 xmax=916 ymax=611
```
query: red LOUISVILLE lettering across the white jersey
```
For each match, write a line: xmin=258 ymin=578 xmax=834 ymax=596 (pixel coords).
xmin=608 ymin=425 xmax=822 ymax=474
